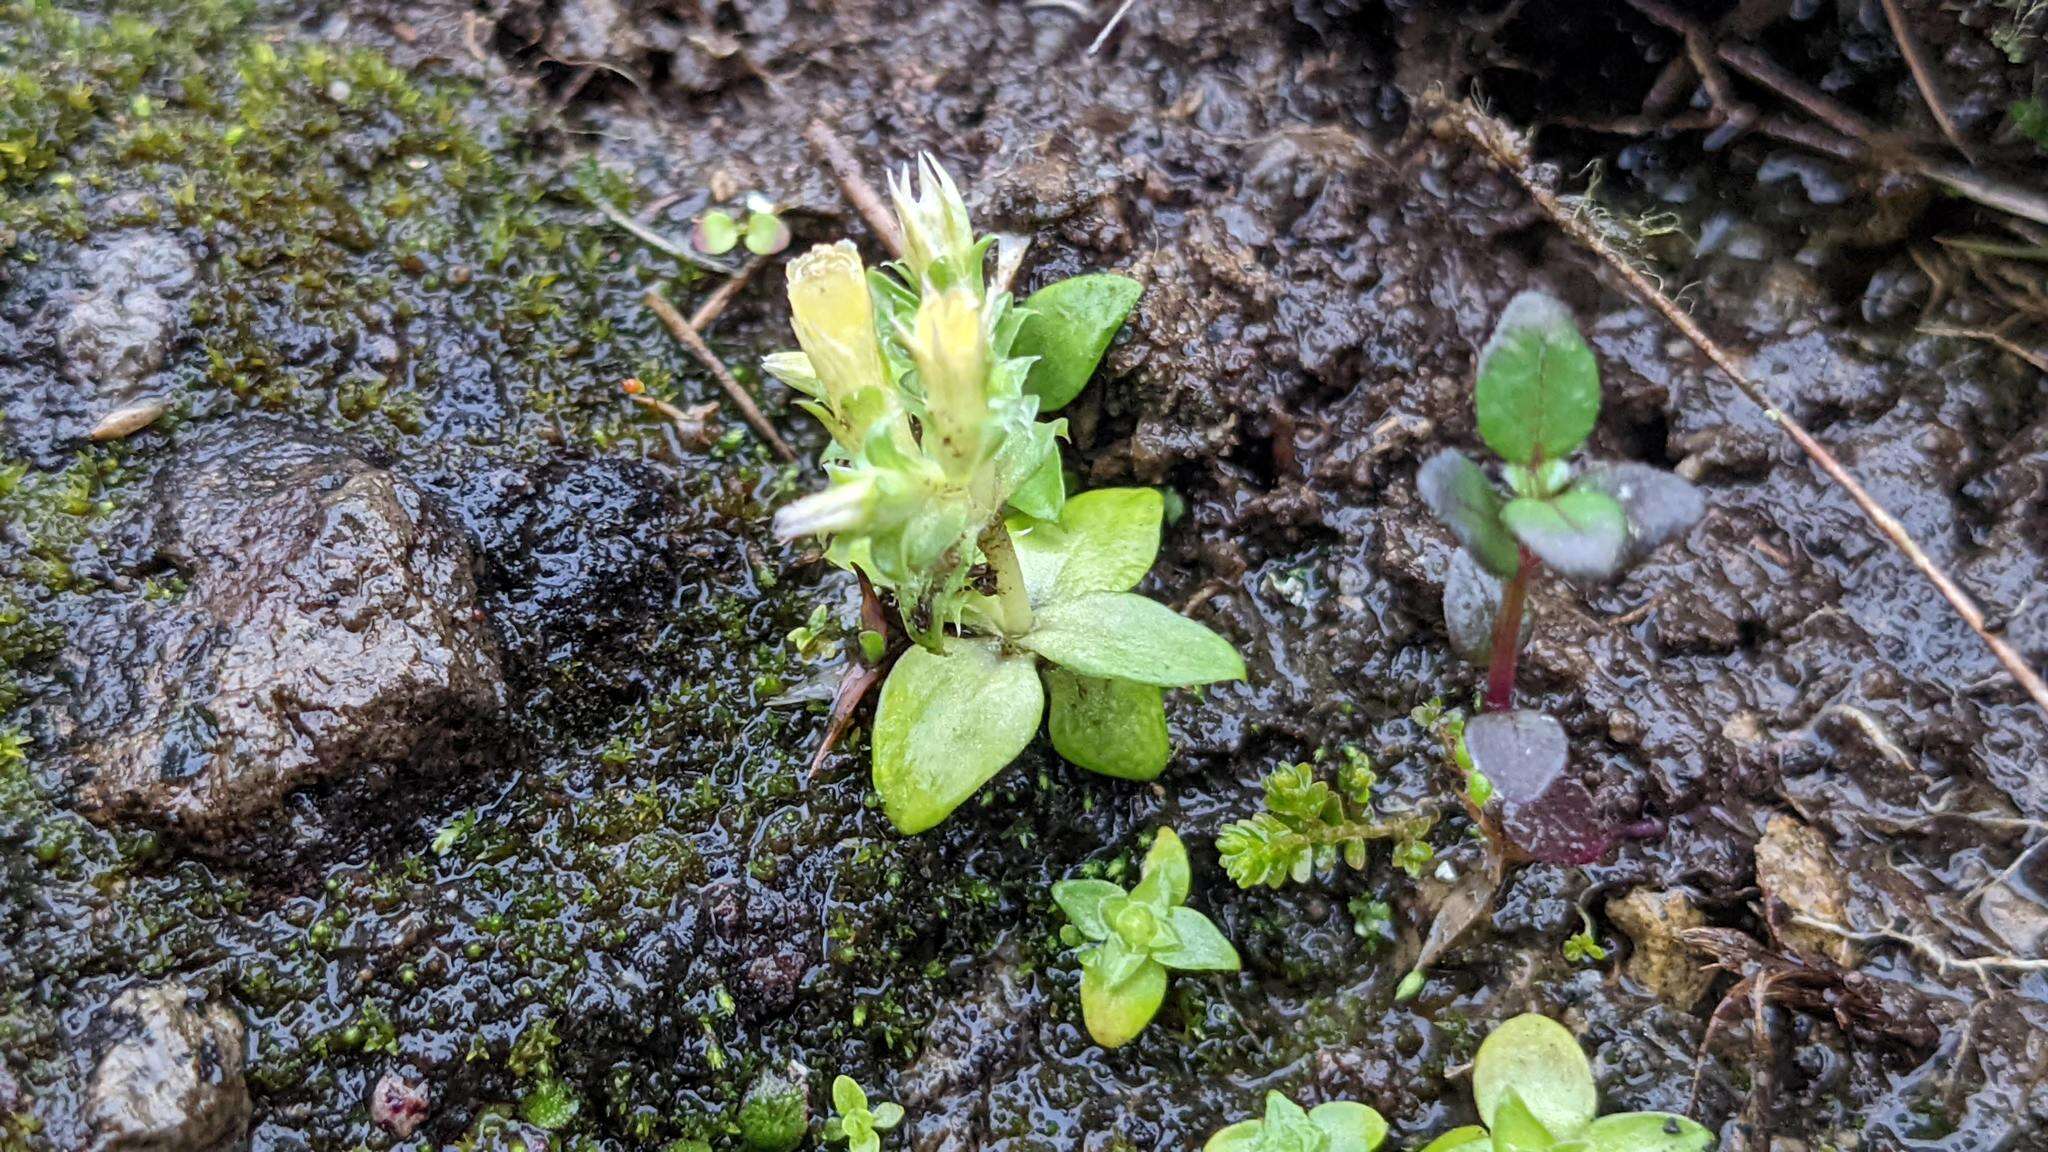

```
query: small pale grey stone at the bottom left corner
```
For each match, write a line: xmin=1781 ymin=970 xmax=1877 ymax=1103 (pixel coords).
xmin=86 ymin=984 xmax=250 ymax=1152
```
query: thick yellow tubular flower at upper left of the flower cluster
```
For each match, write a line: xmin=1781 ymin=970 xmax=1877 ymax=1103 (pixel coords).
xmin=776 ymin=240 xmax=889 ymax=440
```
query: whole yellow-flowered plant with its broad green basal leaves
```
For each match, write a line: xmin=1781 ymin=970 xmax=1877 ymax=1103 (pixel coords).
xmin=764 ymin=160 xmax=1245 ymax=832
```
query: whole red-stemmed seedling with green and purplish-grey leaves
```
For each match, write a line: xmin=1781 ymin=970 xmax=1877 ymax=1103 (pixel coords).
xmin=1415 ymin=291 xmax=1704 ymax=863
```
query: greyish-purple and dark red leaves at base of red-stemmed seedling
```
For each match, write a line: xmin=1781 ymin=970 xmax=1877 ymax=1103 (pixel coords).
xmin=1464 ymin=709 xmax=1614 ymax=865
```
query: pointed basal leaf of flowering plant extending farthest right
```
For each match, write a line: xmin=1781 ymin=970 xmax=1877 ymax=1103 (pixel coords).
xmin=1018 ymin=592 xmax=1245 ymax=689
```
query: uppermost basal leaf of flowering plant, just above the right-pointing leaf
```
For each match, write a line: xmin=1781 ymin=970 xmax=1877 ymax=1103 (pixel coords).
xmin=1010 ymin=488 xmax=1165 ymax=605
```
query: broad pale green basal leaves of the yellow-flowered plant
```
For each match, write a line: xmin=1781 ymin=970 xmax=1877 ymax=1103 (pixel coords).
xmin=874 ymin=488 xmax=1245 ymax=832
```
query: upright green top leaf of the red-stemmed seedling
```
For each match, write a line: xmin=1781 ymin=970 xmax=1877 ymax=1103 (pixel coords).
xmin=1475 ymin=291 xmax=1599 ymax=467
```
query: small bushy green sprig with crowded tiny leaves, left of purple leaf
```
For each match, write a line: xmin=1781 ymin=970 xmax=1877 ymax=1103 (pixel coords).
xmin=1217 ymin=754 xmax=1436 ymax=888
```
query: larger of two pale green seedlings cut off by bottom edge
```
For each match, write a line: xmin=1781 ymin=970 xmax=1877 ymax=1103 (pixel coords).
xmin=1423 ymin=1015 xmax=1714 ymax=1152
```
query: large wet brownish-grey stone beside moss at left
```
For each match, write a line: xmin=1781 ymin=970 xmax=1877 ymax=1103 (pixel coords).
xmin=66 ymin=420 xmax=504 ymax=842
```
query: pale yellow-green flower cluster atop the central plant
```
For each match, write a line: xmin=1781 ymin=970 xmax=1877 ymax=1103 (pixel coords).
xmin=764 ymin=158 xmax=1065 ymax=646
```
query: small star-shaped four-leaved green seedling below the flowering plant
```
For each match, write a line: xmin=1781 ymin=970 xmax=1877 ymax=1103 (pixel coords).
xmin=1053 ymin=828 xmax=1239 ymax=1047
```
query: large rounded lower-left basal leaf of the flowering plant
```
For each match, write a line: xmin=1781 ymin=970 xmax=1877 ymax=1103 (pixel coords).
xmin=874 ymin=640 xmax=1044 ymax=832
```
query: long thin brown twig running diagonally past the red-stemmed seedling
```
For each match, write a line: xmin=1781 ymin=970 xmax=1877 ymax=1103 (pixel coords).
xmin=1425 ymin=94 xmax=2048 ymax=713
